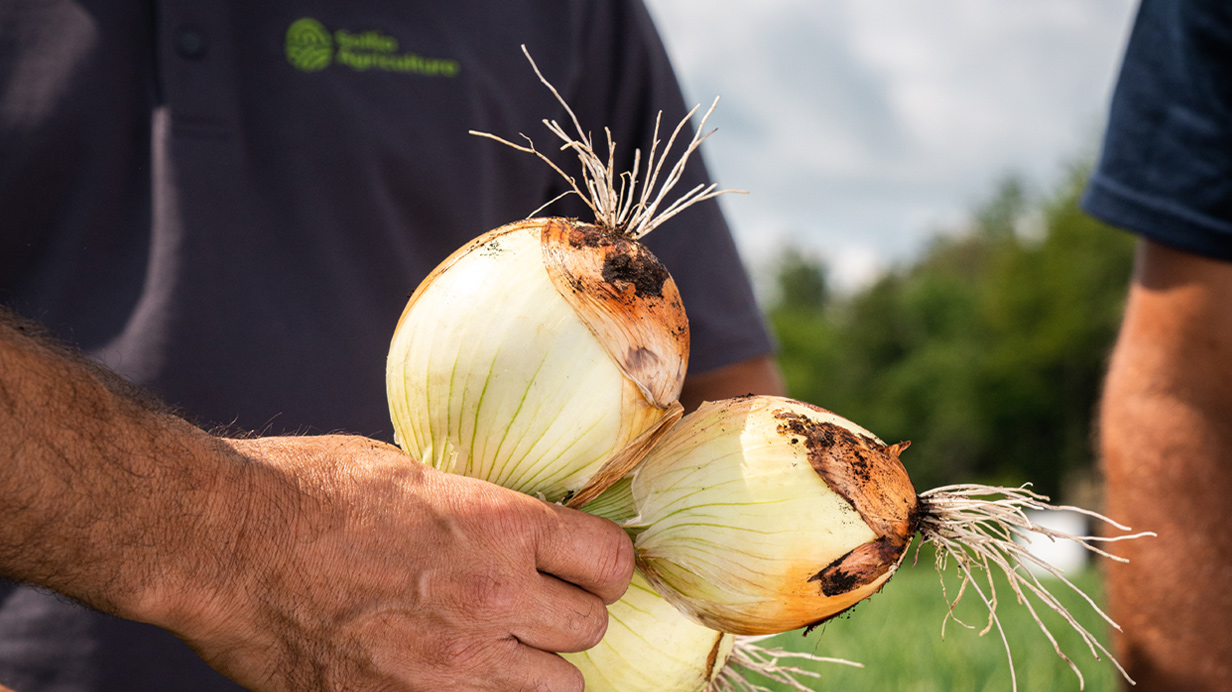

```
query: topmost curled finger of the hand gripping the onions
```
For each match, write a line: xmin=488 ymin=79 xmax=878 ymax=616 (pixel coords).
xmin=536 ymin=505 xmax=633 ymax=603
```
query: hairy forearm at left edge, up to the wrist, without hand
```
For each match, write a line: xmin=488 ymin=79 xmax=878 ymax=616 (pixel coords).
xmin=0 ymin=312 xmax=272 ymax=627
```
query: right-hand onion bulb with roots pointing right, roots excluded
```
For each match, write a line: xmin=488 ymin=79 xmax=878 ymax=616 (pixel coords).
xmin=626 ymin=396 xmax=918 ymax=634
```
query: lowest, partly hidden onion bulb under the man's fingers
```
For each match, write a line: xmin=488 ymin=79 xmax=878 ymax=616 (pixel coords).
xmin=561 ymin=573 xmax=736 ymax=692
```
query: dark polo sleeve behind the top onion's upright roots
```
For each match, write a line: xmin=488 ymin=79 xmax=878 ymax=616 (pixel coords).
xmin=565 ymin=0 xmax=774 ymax=373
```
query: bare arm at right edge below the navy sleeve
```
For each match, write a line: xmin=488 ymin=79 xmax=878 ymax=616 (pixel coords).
xmin=1100 ymin=240 xmax=1232 ymax=692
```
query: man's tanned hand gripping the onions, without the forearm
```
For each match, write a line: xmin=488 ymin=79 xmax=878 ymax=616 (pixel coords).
xmin=172 ymin=436 xmax=633 ymax=692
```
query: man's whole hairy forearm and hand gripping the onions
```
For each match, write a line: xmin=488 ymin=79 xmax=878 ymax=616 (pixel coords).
xmin=0 ymin=313 xmax=633 ymax=692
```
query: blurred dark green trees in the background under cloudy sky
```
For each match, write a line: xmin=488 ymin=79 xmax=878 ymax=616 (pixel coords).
xmin=770 ymin=163 xmax=1133 ymax=497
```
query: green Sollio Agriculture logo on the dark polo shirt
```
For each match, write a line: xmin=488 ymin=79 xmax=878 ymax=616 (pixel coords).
xmin=286 ymin=17 xmax=462 ymax=76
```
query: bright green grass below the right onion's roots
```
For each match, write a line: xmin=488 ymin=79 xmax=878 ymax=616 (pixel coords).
xmin=729 ymin=555 xmax=1120 ymax=692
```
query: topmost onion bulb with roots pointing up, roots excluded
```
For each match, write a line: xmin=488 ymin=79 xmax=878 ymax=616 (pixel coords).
xmin=386 ymin=218 xmax=689 ymax=504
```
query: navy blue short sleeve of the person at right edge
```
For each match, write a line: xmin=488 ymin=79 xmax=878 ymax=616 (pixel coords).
xmin=1083 ymin=0 xmax=1232 ymax=261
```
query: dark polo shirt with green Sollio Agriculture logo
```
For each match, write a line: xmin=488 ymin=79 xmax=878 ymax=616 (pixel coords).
xmin=0 ymin=0 xmax=770 ymax=692
